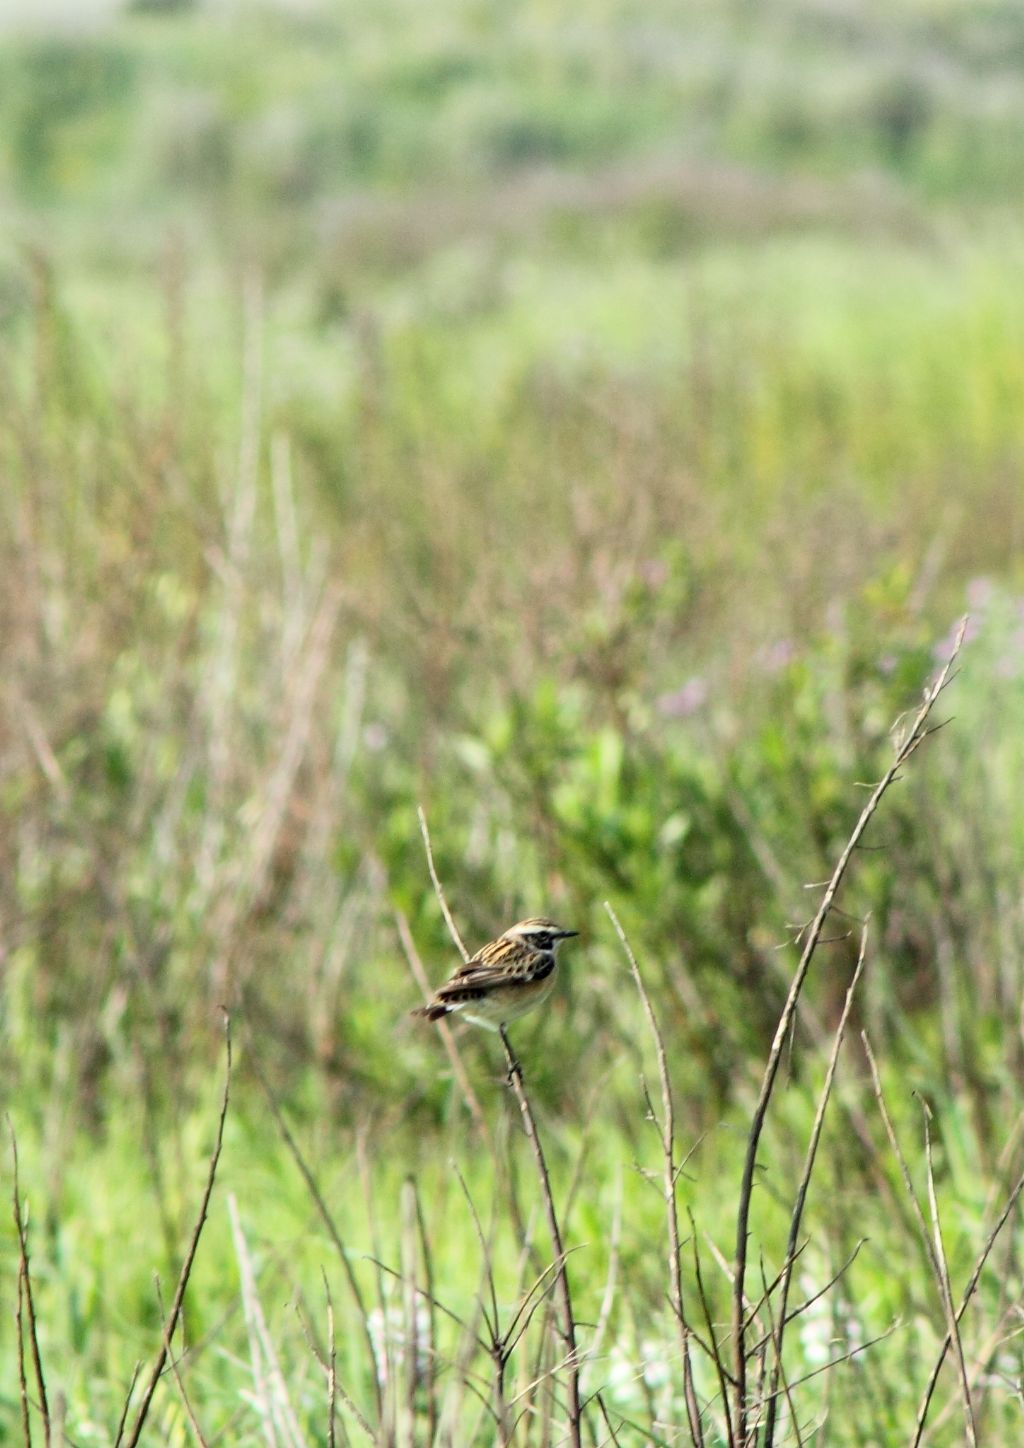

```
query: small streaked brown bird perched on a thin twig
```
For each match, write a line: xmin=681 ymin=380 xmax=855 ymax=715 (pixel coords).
xmin=413 ymin=918 xmax=579 ymax=1031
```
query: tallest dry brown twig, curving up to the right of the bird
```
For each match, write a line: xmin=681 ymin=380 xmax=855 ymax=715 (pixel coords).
xmin=733 ymin=618 xmax=968 ymax=1448
